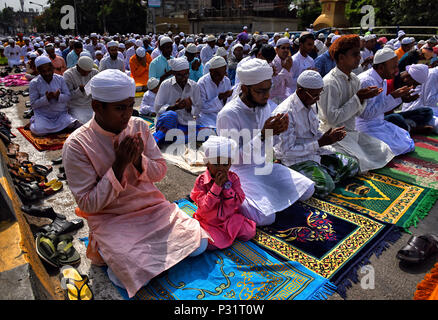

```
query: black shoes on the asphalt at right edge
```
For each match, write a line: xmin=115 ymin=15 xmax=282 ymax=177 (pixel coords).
xmin=397 ymin=234 xmax=438 ymax=263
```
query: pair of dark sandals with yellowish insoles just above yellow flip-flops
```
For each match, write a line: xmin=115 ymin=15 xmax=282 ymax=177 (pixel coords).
xmin=35 ymin=233 xmax=81 ymax=267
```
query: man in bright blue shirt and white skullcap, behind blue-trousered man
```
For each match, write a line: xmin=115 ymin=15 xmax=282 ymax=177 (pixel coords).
xmin=149 ymin=37 xmax=174 ymax=82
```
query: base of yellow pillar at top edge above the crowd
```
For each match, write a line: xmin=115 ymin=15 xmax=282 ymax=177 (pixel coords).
xmin=313 ymin=0 xmax=349 ymax=30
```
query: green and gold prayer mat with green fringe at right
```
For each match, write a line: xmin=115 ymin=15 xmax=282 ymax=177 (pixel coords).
xmin=326 ymin=173 xmax=438 ymax=231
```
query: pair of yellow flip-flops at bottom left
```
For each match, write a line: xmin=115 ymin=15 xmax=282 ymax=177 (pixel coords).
xmin=61 ymin=266 xmax=94 ymax=300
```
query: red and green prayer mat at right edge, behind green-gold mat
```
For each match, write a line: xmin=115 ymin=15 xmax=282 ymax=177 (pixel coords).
xmin=375 ymin=135 xmax=438 ymax=190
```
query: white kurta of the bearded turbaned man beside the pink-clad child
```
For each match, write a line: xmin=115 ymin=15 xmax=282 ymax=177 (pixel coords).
xmin=217 ymin=97 xmax=314 ymax=216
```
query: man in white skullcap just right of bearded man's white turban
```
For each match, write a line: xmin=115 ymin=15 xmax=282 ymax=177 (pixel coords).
xmin=270 ymin=37 xmax=294 ymax=104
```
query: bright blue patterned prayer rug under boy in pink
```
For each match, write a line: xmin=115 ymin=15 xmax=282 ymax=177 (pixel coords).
xmin=106 ymin=199 xmax=336 ymax=300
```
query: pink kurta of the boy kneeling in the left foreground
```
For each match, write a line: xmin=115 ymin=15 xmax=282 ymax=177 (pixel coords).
xmin=62 ymin=118 xmax=208 ymax=297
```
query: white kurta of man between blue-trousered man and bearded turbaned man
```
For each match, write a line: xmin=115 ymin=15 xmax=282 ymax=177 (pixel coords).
xmin=198 ymin=73 xmax=231 ymax=128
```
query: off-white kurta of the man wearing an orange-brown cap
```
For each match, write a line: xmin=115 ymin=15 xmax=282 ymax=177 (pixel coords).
xmin=318 ymin=67 xmax=394 ymax=172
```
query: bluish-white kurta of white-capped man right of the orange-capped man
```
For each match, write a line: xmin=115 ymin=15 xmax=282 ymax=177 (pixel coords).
xmin=356 ymin=68 xmax=415 ymax=156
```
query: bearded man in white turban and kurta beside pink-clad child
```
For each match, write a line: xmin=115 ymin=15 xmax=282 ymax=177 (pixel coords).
xmin=216 ymin=58 xmax=314 ymax=226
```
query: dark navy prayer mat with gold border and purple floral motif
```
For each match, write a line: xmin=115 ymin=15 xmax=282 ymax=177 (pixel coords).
xmin=253 ymin=198 xmax=401 ymax=298
